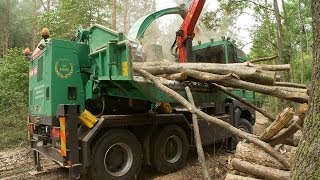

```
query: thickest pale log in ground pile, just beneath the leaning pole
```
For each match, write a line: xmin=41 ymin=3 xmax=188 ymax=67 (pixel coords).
xmin=234 ymin=141 xmax=288 ymax=170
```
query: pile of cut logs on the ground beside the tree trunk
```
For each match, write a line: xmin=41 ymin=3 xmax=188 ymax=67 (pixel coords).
xmin=226 ymin=104 xmax=308 ymax=180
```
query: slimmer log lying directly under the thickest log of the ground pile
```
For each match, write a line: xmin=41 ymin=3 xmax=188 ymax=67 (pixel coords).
xmin=231 ymin=158 xmax=290 ymax=180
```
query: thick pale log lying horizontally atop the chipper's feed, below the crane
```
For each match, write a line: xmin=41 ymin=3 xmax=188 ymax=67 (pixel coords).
xmin=133 ymin=62 xmax=275 ymax=85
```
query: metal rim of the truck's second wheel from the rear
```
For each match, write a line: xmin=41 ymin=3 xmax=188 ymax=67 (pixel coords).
xmin=164 ymin=135 xmax=182 ymax=163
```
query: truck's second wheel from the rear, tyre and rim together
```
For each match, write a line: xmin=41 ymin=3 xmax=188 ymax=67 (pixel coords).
xmin=151 ymin=125 xmax=189 ymax=173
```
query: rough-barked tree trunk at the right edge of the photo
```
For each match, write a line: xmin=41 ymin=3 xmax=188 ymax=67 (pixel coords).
xmin=291 ymin=0 xmax=320 ymax=180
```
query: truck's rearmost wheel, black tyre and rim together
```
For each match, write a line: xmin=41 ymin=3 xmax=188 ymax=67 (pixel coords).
xmin=90 ymin=130 xmax=142 ymax=180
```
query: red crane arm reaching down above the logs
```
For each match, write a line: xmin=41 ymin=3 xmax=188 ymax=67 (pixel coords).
xmin=177 ymin=0 xmax=206 ymax=63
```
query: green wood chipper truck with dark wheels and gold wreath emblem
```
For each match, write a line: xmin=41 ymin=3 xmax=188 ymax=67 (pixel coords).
xmin=28 ymin=4 xmax=255 ymax=179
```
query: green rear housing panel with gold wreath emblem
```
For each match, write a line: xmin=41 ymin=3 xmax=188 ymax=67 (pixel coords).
xmin=29 ymin=39 xmax=89 ymax=117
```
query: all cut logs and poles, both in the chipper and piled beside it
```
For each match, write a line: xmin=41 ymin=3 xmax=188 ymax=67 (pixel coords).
xmin=132 ymin=55 xmax=309 ymax=180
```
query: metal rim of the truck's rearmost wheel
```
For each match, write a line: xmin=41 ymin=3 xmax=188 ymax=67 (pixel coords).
xmin=104 ymin=143 xmax=133 ymax=177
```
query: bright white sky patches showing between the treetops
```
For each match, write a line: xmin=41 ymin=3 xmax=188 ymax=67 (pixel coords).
xmin=156 ymin=0 xmax=254 ymax=53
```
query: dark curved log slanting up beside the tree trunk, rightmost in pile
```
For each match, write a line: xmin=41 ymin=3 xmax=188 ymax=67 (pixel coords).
xmin=269 ymin=104 xmax=309 ymax=146
